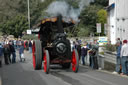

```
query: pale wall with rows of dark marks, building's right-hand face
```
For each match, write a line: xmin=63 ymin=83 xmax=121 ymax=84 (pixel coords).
xmin=116 ymin=0 xmax=128 ymax=40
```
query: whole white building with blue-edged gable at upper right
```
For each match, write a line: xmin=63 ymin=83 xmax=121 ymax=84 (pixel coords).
xmin=107 ymin=0 xmax=128 ymax=44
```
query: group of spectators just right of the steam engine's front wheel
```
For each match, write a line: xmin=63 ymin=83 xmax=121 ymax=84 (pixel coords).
xmin=71 ymin=39 xmax=99 ymax=69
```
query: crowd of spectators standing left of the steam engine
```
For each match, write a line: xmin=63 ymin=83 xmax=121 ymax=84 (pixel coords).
xmin=0 ymin=39 xmax=32 ymax=67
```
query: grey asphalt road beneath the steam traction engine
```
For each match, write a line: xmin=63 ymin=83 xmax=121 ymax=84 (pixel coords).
xmin=0 ymin=52 xmax=128 ymax=85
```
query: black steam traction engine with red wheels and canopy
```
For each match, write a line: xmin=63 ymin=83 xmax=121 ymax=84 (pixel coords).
xmin=32 ymin=16 xmax=79 ymax=74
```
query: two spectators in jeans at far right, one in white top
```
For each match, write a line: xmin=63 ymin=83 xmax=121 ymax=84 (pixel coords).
xmin=114 ymin=38 xmax=128 ymax=76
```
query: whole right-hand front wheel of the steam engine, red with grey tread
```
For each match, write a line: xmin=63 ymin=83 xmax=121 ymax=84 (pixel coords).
xmin=72 ymin=49 xmax=79 ymax=72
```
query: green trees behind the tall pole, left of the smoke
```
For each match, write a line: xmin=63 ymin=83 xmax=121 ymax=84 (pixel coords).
xmin=0 ymin=0 xmax=54 ymax=37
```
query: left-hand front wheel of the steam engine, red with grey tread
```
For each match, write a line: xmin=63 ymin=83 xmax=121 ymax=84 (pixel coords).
xmin=43 ymin=50 xmax=50 ymax=74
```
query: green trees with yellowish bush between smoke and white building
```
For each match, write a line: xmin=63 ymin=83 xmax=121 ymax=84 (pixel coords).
xmin=74 ymin=0 xmax=108 ymax=36
